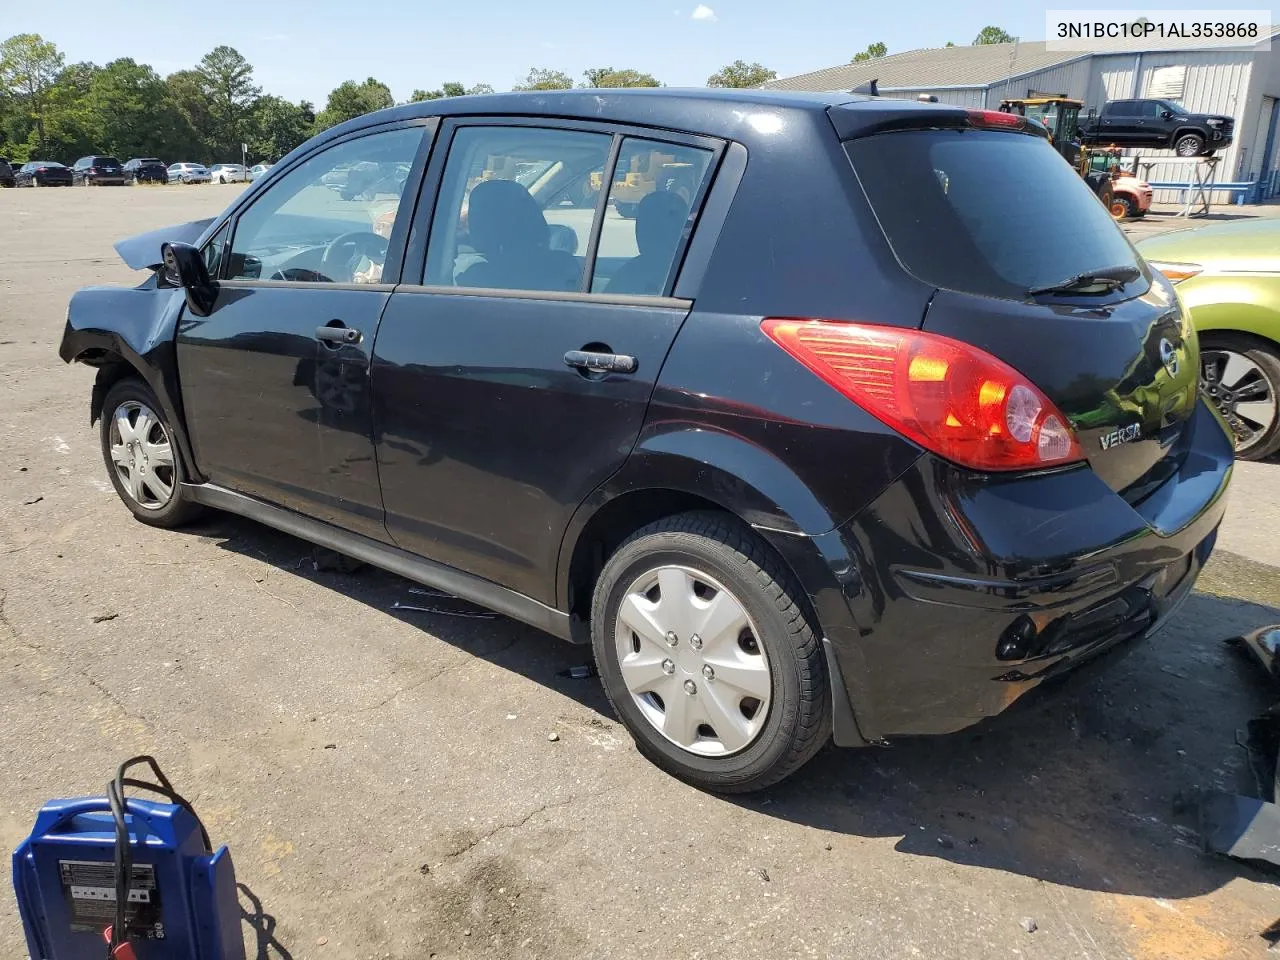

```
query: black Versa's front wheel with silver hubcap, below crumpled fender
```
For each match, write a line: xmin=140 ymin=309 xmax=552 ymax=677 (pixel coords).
xmin=99 ymin=378 xmax=202 ymax=527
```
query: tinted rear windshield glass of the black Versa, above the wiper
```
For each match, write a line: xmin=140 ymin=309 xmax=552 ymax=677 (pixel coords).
xmin=846 ymin=129 xmax=1138 ymax=300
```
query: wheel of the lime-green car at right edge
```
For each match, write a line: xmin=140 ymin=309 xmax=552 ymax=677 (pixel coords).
xmin=1201 ymin=334 xmax=1280 ymax=460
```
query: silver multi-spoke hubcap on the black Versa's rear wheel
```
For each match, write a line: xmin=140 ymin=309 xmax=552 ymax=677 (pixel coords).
xmin=614 ymin=566 xmax=773 ymax=756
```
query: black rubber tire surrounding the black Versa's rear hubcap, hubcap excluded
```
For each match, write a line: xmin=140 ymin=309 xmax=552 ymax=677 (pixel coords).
xmin=591 ymin=512 xmax=831 ymax=794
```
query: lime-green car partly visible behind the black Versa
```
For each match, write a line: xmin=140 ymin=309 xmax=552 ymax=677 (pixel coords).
xmin=1138 ymin=219 xmax=1280 ymax=460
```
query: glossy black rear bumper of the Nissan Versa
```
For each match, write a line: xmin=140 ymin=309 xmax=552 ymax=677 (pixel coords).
xmin=762 ymin=403 xmax=1233 ymax=742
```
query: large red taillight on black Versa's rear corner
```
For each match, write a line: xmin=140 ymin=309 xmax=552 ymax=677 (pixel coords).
xmin=762 ymin=317 xmax=1084 ymax=470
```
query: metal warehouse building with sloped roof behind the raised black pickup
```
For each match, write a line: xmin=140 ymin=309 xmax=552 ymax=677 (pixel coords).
xmin=765 ymin=32 xmax=1280 ymax=202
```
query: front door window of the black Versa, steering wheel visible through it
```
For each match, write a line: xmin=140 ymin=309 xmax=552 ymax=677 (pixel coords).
xmin=227 ymin=127 xmax=422 ymax=283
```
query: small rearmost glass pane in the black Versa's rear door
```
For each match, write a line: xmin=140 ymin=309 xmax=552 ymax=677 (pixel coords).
xmin=591 ymin=137 xmax=712 ymax=296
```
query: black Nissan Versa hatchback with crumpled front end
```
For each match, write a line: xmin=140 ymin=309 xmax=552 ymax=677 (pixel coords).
xmin=61 ymin=90 xmax=1231 ymax=791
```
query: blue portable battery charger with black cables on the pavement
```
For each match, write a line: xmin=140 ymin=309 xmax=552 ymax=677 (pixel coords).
xmin=13 ymin=756 xmax=244 ymax=960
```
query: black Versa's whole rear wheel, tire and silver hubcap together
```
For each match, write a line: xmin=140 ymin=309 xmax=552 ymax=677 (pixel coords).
xmin=591 ymin=513 xmax=831 ymax=792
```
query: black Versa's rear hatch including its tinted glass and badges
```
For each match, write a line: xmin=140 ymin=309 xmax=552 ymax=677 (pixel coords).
xmin=846 ymin=116 xmax=1199 ymax=503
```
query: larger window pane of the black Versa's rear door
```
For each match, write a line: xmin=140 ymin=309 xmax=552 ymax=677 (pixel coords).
xmin=424 ymin=127 xmax=612 ymax=292
